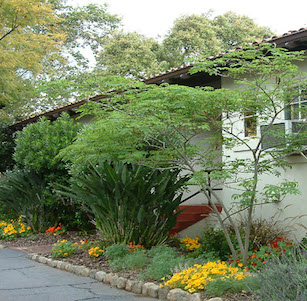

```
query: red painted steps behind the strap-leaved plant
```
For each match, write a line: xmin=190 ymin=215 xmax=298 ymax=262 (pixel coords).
xmin=170 ymin=204 xmax=222 ymax=235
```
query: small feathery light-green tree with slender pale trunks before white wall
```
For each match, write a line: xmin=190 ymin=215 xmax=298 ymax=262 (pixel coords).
xmin=61 ymin=45 xmax=306 ymax=265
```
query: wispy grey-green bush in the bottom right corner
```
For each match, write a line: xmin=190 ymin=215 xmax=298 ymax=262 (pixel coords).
xmin=247 ymin=250 xmax=307 ymax=301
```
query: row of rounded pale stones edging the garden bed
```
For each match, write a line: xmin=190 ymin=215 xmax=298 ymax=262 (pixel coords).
xmin=26 ymin=252 xmax=223 ymax=301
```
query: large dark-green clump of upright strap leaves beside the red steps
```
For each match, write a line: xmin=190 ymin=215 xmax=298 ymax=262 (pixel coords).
xmin=60 ymin=162 xmax=188 ymax=248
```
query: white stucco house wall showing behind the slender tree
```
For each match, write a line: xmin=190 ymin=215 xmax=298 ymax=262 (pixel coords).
xmin=222 ymin=61 xmax=307 ymax=240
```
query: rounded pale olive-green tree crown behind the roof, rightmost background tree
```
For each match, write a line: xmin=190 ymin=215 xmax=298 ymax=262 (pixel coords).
xmin=162 ymin=11 xmax=272 ymax=67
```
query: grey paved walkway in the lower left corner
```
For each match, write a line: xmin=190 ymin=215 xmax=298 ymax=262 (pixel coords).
xmin=0 ymin=249 xmax=157 ymax=301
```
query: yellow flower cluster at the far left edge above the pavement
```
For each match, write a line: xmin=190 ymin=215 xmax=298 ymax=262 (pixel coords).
xmin=0 ymin=217 xmax=31 ymax=240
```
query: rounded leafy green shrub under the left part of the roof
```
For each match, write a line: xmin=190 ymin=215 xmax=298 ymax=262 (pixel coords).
xmin=14 ymin=113 xmax=89 ymax=230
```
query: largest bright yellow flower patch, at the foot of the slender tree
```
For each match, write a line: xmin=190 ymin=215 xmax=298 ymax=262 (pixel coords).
xmin=164 ymin=260 xmax=246 ymax=293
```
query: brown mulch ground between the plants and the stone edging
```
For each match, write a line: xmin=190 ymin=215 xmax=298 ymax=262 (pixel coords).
xmin=0 ymin=232 xmax=256 ymax=301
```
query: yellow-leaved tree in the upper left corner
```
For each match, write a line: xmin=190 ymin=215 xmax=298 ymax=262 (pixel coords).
xmin=0 ymin=0 xmax=65 ymax=120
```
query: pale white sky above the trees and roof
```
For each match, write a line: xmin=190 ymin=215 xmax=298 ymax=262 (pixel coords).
xmin=70 ymin=0 xmax=307 ymax=38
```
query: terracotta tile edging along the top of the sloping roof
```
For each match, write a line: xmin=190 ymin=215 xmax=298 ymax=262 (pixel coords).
xmin=12 ymin=27 xmax=307 ymax=128
